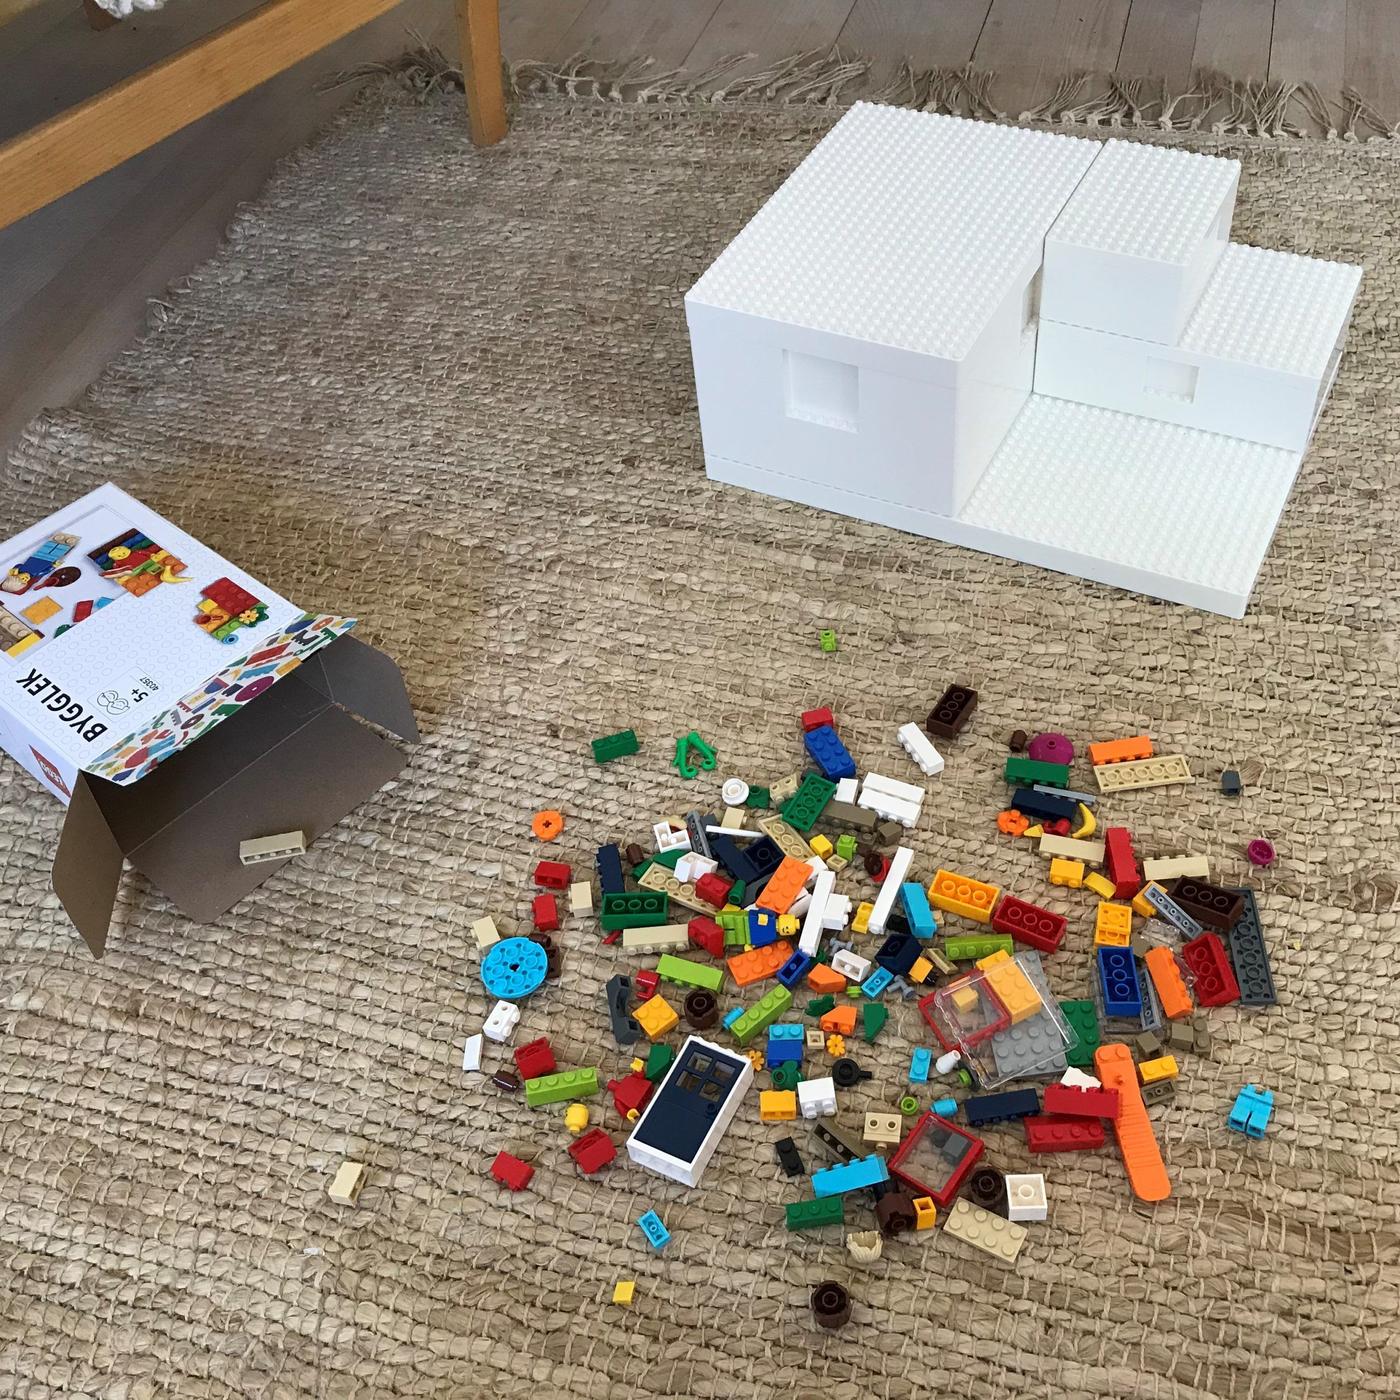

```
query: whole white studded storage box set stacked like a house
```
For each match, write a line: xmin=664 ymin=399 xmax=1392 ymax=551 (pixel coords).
xmin=686 ymin=102 xmax=1359 ymax=616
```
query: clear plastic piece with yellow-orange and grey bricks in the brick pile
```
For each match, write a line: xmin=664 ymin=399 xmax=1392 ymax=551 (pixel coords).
xmin=925 ymin=953 xmax=1078 ymax=1089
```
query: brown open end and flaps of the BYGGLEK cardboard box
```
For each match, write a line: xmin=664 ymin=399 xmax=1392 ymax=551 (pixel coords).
xmin=53 ymin=636 xmax=419 ymax=956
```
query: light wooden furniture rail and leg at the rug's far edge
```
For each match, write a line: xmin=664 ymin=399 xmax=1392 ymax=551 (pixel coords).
xmin=0 ymin=0 xmax=505 ymax=228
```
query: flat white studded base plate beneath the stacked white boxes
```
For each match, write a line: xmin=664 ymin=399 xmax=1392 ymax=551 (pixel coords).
xmin=706 ymin=395 xmax=1302 ymax=617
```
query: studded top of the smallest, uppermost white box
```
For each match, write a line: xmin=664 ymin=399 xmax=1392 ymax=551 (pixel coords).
xmin=1049 ymin=141 xmax=1239 ymax=263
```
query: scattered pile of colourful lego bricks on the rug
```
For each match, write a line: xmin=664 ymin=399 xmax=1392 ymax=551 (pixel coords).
xmin=463 ymin=683 xmax=1275 ymax=1327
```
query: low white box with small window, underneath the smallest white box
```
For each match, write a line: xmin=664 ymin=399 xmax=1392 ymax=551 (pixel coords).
xmin=1036 ymin=244 xmax=1361 ymax=452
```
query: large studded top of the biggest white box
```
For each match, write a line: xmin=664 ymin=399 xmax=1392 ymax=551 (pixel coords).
xmin=686 ymin=102 xmax=1099 ymax=360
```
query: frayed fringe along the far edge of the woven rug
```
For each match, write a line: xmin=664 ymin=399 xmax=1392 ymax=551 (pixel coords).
xmin=333 ymin=40 xmax=1400 ymax=141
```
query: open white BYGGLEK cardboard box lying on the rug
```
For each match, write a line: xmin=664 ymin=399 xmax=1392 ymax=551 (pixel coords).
xmin=0 ymin=484 xmax=417 ymax=953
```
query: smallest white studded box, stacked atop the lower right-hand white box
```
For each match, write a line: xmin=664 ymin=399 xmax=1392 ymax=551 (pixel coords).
xmin=1040 ymin=141 xmax=1240 ymax=344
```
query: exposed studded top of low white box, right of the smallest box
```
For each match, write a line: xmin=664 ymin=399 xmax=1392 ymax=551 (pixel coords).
xmin=1179 ymin=244 xmax=1361 ymax=379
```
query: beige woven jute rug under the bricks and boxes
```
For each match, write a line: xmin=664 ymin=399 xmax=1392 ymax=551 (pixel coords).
xmin=0 ymin=63 xmax=1400 ymax=1400
